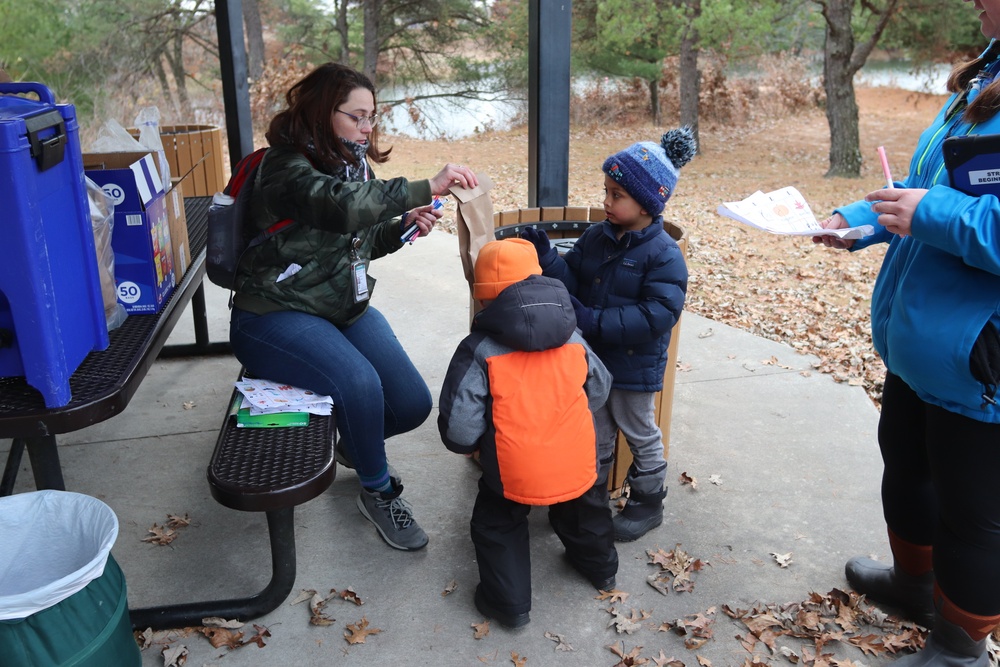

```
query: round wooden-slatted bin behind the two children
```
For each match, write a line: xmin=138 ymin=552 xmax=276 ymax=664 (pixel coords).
xmin=493 ymin=206 xmax=688 ymax=490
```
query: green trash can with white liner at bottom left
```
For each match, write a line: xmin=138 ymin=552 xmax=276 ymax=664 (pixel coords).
xmin=0 ymin=491 xmax=142 ymax=667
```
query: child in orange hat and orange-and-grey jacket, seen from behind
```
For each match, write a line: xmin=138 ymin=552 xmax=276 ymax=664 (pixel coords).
xmin=438 ymin=239 xmax=618 ymax=628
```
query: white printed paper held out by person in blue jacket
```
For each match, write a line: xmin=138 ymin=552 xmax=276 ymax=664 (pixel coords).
xmin=718 ymin=187 xmax=875 ymax=239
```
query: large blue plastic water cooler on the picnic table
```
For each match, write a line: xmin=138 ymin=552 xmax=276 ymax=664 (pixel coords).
xmin=0 ymin=83 xmax=108 ymax=408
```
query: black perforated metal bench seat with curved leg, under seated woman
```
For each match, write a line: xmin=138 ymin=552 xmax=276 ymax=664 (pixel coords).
xmin=130 ymin=370 xmax=337 ymax=630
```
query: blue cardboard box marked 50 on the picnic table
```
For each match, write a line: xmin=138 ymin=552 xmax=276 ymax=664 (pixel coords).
xmin=83 ymin=151 xmax=176 ymax=314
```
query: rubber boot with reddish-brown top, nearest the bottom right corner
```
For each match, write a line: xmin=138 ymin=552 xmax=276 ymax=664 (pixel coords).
xmin=892 ymin=587 xmax=1000 ymax=667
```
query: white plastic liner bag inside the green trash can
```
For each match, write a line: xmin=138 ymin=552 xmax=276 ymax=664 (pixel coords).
xmin=0 ymin=491 xmax=118 ymax=621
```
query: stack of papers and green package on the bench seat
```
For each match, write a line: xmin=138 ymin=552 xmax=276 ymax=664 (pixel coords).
xmin=235 ymin=378 xmax=333 ymax=427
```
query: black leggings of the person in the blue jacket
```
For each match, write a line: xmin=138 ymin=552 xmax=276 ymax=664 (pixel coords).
xmin=878 ymin=373 xmax=1000 ymax=616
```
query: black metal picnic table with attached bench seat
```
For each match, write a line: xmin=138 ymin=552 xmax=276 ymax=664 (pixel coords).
xmin=0 ymin=197 xmax=336 ymax=630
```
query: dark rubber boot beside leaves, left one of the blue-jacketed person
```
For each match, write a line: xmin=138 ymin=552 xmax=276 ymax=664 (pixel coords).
xmin=844 ymin=530 xmax=934 ymax=628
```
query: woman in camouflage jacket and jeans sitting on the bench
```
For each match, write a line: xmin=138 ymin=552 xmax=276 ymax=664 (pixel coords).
xmin=230 ymin=63 xmax=477 ymax=551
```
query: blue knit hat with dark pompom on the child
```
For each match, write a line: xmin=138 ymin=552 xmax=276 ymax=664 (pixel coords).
xmin=601 ymin=127 xmax=698 ymax=216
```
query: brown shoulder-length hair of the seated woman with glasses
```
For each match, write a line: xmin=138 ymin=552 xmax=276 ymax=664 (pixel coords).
xmin=264 ymin=63 xmax=392 ymax=166
